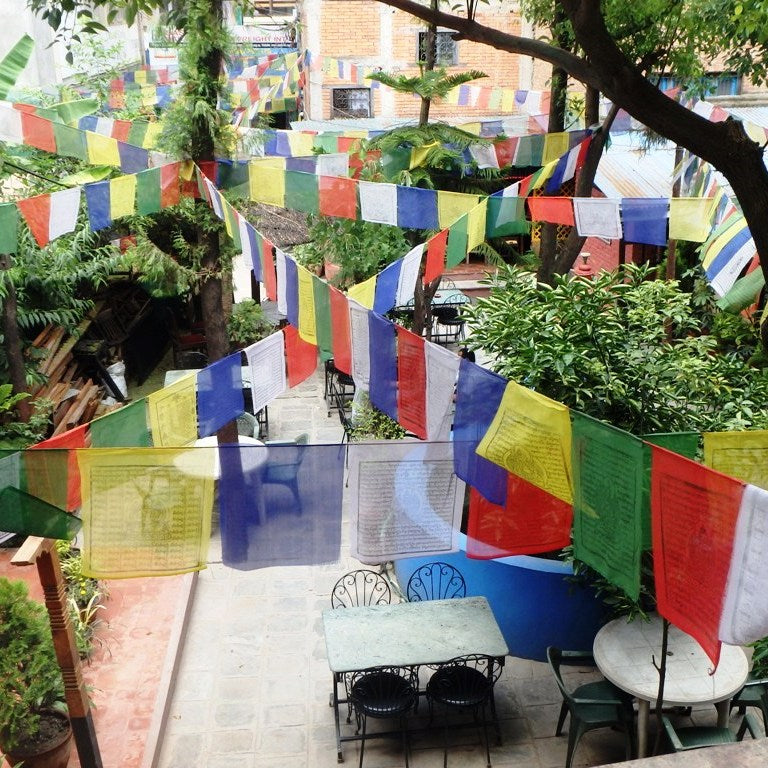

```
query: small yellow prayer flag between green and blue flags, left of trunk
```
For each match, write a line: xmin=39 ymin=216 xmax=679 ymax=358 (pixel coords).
xmin=147 ymin=373 xmax=197 ymax=448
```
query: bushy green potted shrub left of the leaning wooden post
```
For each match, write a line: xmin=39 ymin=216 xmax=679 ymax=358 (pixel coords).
xmin=0 ymin=578 xmax=72 ymax=768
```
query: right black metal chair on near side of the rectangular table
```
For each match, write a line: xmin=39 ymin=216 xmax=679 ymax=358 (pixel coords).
xmin=426 ymin=654 xmax=502 ymax=768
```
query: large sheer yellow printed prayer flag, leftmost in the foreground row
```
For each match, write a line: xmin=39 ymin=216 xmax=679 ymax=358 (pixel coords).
xmin=77 ymin=448 xmax=216 ymax=579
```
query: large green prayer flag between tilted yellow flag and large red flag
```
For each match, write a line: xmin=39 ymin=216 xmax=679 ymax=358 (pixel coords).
xmin=571 ymin=411 xmax=650 ymax=600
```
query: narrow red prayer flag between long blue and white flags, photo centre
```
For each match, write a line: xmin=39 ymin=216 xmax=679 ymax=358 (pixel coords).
xmin=395 ymin=325 xmax=427 ymax=440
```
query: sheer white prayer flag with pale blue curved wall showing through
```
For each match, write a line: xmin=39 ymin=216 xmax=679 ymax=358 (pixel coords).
xmin=349 ymin=440 xmax=464 ymax=564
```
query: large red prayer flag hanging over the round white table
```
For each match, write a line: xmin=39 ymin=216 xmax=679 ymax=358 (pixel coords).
xmin=651 ymin=445 xmax=744 ymax=667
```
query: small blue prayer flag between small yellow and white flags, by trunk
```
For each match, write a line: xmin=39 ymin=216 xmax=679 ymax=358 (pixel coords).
xmin=197 ymin=352 xmax=245 ymax=437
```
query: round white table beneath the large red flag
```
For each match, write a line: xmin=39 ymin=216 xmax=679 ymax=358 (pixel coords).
xmin=593 ymin=616 xmax=749 ymax=758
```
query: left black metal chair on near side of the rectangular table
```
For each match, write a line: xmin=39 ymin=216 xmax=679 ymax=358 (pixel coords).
xmin=346 ymin=667 xmax=418 ymax=768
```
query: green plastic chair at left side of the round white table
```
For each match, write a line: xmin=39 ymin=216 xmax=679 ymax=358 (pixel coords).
xmin=547 ymin=646 xmax=635 ymax=768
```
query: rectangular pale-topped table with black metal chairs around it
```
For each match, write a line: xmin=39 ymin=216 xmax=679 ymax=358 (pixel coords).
xmin=323 ymin=597 xmax=509 ymax=762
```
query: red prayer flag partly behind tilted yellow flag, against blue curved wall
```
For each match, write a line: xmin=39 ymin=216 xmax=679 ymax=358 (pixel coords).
xmin=467 ymin=473 xmax=573 ymax=560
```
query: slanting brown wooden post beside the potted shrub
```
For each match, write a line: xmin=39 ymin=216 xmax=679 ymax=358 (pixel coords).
xmin=11 ymin=536 xmax=103 ymax=768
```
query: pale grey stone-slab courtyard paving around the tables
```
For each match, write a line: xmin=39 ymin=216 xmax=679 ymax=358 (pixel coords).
xmin=156 ymin=373 xmax=737 ymax=768
